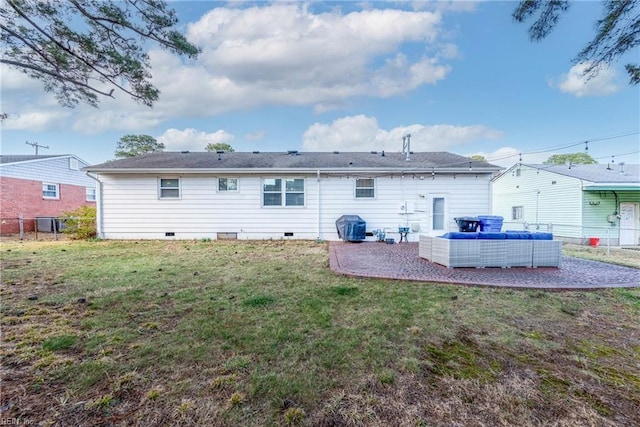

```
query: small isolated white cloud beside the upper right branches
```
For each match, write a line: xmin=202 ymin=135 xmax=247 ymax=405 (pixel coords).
xmin=549 ymin=63 xmax=620 ymax=98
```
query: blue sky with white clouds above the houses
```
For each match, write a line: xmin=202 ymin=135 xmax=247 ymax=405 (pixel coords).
xmin=0 ymin=1 xmax=640 ymax=167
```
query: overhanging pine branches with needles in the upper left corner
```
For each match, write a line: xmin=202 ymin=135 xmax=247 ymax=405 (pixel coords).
xmin=0 ymin=0 xmax=199 ymax=107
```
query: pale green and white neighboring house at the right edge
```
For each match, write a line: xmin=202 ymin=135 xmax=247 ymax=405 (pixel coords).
xmin=492 ymin=163 xmax=640 ymax=246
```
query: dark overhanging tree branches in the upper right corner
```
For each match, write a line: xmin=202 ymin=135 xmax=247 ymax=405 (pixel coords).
xmin=513 ymin=0 xmax=640 ymax=84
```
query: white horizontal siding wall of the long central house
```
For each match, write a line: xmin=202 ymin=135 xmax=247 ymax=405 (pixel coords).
xmin=100 ymin=174 xmax=490 ymax=241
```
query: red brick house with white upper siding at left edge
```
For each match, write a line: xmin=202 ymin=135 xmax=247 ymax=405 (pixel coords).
xmin=0 ymin=154 xmax=96 ymax=234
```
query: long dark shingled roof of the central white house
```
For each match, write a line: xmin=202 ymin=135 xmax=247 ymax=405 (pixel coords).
xmin=86 ymin=151 xmax=502 ymax=173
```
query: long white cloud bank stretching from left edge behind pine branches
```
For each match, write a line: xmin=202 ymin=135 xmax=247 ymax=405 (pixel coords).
xmin=1 ymin=2 xmax=464 ymax=135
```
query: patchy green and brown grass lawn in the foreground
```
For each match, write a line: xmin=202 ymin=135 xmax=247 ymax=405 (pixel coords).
xmin=0 ymin=241 xmax=640 ymax=426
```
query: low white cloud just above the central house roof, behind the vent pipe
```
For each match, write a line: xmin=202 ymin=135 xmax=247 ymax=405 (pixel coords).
xmin=302 ymin=115 xmax=502 ymax=151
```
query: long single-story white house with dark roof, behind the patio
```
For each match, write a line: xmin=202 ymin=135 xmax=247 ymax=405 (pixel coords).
xmin=86 ymin=151 xmax=501 ymax=241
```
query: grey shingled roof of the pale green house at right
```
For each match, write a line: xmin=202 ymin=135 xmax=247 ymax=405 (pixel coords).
xmin=526 ymin=163 xmax=640 ymax=184
